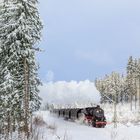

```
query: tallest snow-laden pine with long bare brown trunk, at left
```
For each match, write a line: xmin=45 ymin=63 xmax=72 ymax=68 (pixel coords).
xmin=0 ymin=0 xmax=42 ymax=137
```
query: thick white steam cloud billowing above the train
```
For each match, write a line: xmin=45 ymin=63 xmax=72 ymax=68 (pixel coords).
xmin=40 ymin=80 xmax=100 ymax=105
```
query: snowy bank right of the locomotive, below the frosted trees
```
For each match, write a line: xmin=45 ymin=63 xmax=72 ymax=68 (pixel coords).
xmin=101 ymin=103 xmax=140 ymax=126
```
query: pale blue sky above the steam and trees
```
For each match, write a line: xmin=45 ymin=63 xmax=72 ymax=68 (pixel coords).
xmin=37 ymin=0 xmax=140 ymax=82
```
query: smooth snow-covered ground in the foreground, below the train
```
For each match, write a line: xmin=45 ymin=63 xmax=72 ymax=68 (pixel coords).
xmin=33 ymin=111 xmax=140 ymax=140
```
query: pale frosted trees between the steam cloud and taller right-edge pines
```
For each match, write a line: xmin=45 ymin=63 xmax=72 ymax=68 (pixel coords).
xmin=95 ymin=72 xmax=128 ymax=103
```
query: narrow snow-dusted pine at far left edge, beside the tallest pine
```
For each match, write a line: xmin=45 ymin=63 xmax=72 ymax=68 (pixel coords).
xmin=0 ymin=49 xmax=13 ymax=139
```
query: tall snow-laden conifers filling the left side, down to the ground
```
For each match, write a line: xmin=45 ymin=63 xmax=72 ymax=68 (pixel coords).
xmin=0 ymin=0 xmax=42 ymax=140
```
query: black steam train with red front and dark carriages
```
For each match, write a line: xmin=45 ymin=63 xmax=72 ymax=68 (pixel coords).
xmin=52 ymin=105 xmax=107 ymax=128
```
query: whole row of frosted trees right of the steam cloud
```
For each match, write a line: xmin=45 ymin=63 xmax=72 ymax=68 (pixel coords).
xmin=95 ymin=56 xmax=140 ymax=105
